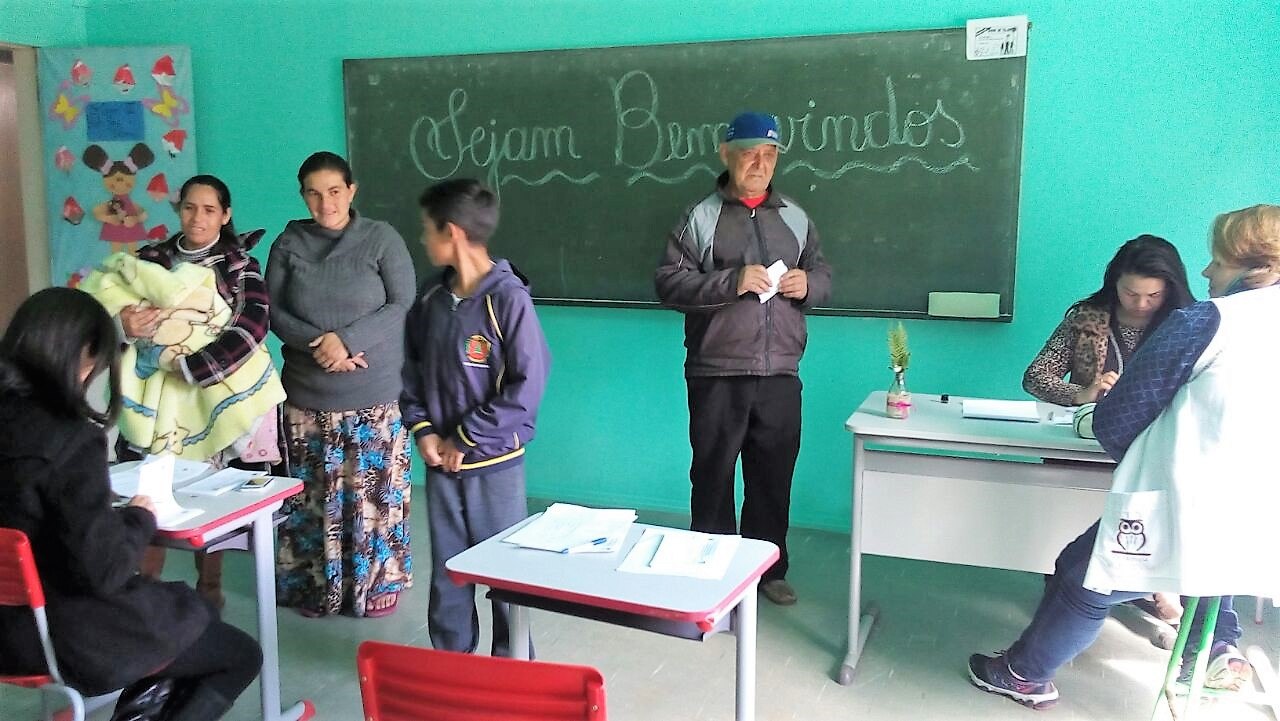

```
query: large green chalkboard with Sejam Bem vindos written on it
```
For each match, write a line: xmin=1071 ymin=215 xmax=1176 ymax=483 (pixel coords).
xmin=343 ymin=28 xmax=1027 ymax=320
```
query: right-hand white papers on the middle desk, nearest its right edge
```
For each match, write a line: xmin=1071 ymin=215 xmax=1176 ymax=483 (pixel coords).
xmin=618 ymin=528 xmax=741 ymax=579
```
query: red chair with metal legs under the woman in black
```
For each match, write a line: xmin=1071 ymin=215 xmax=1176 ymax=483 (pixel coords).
xmin=0 ymin=529 xmax=120 ymax=721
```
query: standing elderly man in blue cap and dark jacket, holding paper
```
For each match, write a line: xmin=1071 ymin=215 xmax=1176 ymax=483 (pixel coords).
xmin=654 ymin=113 xmax=831 ymax=606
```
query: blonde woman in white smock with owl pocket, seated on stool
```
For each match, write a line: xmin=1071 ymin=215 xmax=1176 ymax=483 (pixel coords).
xmin=969 ymin=205 xmax=1280 ymax=708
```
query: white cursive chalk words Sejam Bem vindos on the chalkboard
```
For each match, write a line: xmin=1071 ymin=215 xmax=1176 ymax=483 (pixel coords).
xmin=408 ymin=70 xmax=979 ymax=192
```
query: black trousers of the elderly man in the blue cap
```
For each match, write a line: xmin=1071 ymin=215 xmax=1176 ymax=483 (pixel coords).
xmin=687 ymin=375 xmax=800 ymax=580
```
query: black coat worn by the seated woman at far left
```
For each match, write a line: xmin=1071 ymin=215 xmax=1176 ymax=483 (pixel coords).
xmin=0 ymin=361 xmax=212 ymax=694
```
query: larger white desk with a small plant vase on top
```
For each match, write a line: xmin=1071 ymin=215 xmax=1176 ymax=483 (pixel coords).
xmin=837 ymin=391 xmax=1115 ymax=684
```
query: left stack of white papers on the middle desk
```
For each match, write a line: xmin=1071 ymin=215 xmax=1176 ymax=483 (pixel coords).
xmin=503 ymin=503 xmax=636 ymax=553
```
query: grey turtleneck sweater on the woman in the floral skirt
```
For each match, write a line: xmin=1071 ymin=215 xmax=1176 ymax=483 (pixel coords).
xmin=266 ymin=210 xmax=416 ymax=411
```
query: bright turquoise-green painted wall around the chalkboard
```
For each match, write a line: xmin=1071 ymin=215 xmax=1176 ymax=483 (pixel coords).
xmin=86 ymin=0 xmax=1280 ymax=529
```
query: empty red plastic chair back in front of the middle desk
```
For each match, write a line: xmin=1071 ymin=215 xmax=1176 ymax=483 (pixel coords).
xmin=356 ymin=640 xmax=605 ymax=721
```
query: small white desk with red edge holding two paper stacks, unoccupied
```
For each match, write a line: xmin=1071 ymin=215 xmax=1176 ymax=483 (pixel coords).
xmin=444 ymin=515 xmax=778 ymax=721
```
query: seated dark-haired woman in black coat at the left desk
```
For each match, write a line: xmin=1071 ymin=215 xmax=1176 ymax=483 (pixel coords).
xmin=0 ymin=288 xmax=262 ymax=721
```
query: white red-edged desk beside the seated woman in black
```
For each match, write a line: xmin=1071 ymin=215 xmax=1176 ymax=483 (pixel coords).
xmin=156 ymin=478 xmax=315 ymax=721
